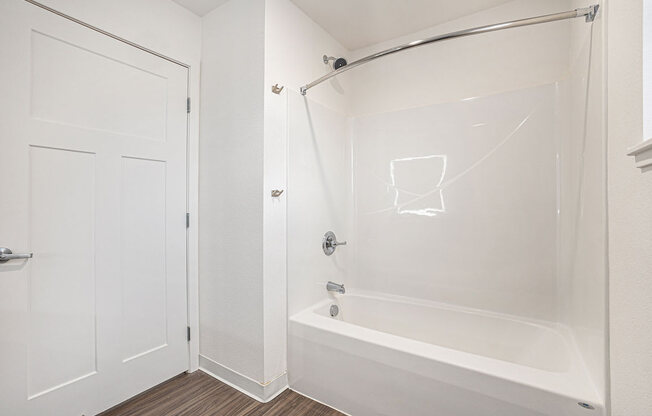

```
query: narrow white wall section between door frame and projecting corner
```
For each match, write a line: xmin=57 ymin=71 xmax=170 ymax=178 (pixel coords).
xmin=199 ymin=0 xmax=265 ymax=383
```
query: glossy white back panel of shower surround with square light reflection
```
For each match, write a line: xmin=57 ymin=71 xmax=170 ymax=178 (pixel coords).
xmin=349 ymin=84 xmax=560 ymax=320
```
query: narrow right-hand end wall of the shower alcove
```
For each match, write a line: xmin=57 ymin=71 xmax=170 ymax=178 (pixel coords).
xmin=558 ymin=0 xmax=607 ymax=404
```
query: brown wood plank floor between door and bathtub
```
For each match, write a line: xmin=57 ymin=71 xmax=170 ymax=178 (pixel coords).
xmin=99 ymin=371 xmax=344 ymax=416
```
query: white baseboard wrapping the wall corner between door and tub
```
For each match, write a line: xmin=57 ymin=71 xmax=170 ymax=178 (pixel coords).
xmin=199 ymin=354 xmax=288 ymax=403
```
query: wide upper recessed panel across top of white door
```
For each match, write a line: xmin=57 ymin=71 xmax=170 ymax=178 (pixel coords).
xmin=31 ymin=31 xmax=168 ymax=141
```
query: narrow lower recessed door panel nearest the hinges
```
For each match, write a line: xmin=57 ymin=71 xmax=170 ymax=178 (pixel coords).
xmin=120 ymin=157 xmax=167 ymax=361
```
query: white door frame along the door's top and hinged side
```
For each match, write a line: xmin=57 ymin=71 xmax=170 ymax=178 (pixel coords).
xmin=24 ymin=0 xmax=200 ymax=373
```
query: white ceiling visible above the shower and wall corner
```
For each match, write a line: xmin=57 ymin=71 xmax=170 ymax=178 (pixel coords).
xmin=173 ymin=0 xmax=510 ymax=50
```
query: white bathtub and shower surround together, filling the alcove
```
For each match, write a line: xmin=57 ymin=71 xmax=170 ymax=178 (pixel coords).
xmin=287 ymin=1 xmax=606 ymax=416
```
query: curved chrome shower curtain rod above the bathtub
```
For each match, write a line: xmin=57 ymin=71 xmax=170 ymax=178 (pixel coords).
xmin=300 ymin=4 xmax=600 ymax=95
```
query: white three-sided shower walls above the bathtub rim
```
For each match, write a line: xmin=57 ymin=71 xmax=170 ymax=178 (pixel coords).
xmin=287 ymin=0 xmax=606 ymax=404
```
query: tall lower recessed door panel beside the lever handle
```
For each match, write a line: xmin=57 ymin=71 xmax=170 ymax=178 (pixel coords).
xmin=28 ymin=146 xmax=97 ymax=398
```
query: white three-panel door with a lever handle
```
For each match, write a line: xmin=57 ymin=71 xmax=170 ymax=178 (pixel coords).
xmin=0 ymin=0 xmax=188 ymax=416
